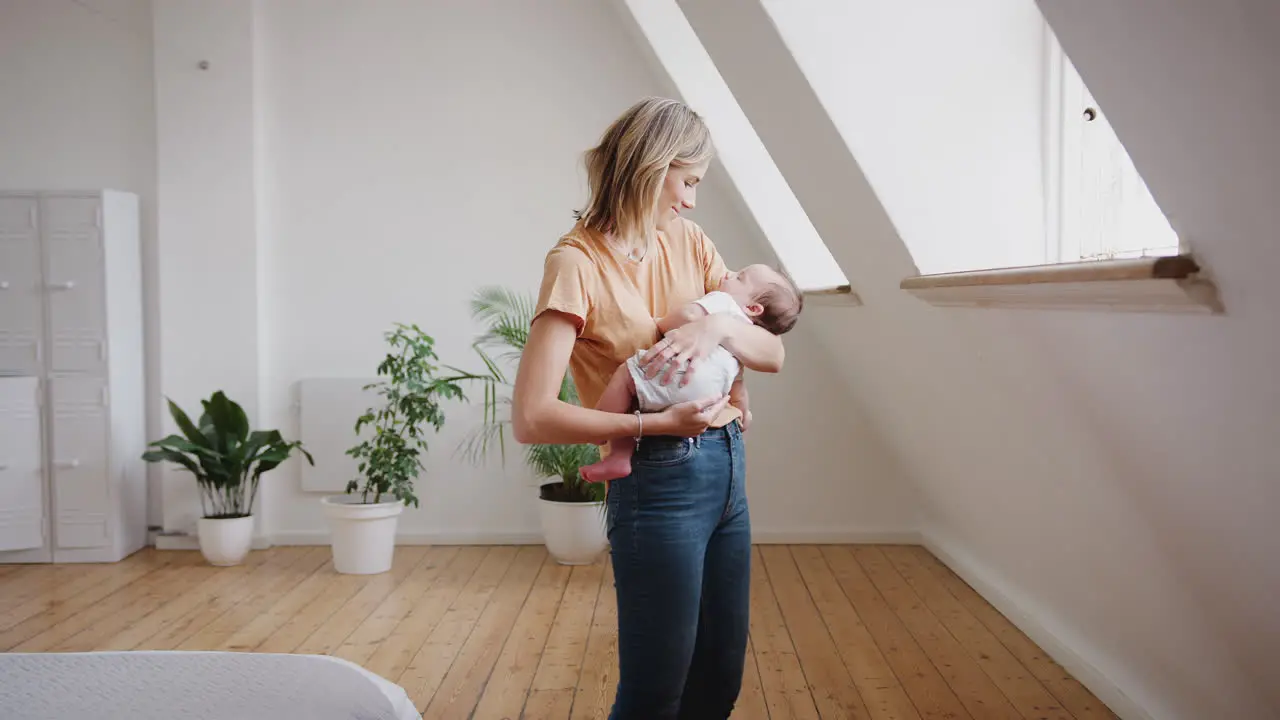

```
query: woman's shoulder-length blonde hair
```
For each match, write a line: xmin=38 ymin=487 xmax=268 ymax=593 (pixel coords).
xmin=573 ymin=97 xmax=716 ymax=238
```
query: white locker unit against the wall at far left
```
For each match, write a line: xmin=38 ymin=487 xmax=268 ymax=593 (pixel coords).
xmin=0 ymin=191 xmax=147 ymax=562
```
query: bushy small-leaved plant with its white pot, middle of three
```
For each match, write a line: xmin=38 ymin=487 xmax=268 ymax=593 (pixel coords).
xmin=321 ymin=323 xmax=466 ymax=575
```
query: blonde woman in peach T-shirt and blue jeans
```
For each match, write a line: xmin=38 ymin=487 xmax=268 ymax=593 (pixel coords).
xmin=513 ymin=99 xmax=783 ymax=720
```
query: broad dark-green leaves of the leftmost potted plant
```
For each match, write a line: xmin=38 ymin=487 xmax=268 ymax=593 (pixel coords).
xmin=142 ymin=391 xmax=315 ymax=519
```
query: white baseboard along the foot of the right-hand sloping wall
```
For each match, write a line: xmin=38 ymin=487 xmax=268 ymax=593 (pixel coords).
xmin=922 ymin=532 xmax=1155 ymax=720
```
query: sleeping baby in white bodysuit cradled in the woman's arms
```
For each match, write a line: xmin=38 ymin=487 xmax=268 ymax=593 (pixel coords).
xmin=581 ymin=265 xmax=804 ymax=483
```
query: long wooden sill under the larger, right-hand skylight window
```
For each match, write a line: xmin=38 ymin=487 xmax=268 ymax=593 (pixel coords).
xmin=900 ymin=255 xmax=1224 ymax=314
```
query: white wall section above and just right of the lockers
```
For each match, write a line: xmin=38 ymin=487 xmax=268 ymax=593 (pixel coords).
xmin=0 ymin=0 xmax=161 ymax=523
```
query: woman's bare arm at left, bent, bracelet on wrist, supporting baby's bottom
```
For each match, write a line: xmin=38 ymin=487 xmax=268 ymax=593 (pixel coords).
xmin=511 ymin=311 xmax=728 ymax=445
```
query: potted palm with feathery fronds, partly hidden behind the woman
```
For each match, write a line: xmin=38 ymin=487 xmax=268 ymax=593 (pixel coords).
xmin=462 ymin=287 xmax=608 ymax=565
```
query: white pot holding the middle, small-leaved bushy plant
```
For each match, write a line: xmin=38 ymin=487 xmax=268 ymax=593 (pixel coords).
xmin=320 ymin=495 xmax=404 ymax=575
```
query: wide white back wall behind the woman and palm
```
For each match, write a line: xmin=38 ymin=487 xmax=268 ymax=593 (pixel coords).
xmin=247 ymin=0 xmax=913 ymax=541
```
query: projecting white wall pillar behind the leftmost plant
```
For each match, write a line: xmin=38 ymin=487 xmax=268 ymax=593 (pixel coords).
xmin=154 ymin=0 xmax=262 ymax=532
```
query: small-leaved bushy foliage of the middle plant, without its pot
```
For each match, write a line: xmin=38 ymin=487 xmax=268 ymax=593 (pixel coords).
xmin=347 ymin=323 xmax=474 ymax=507
